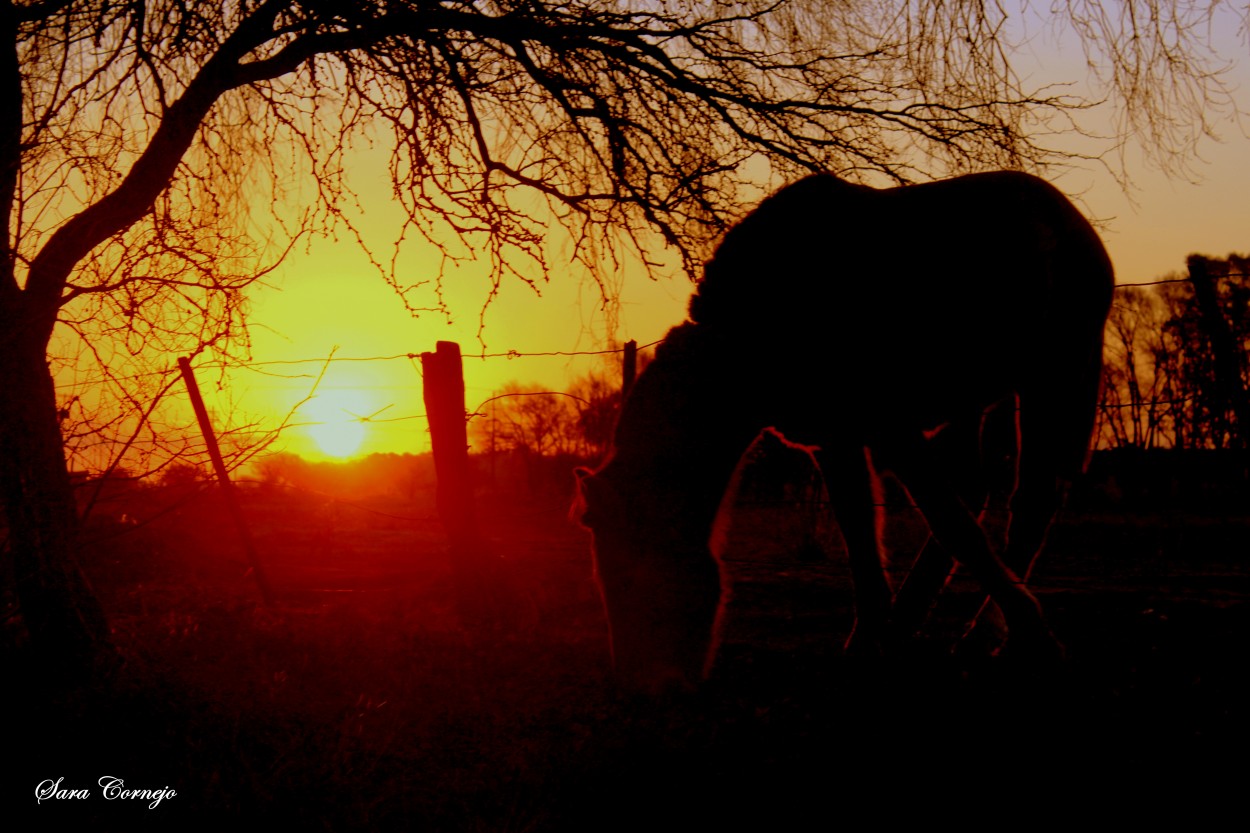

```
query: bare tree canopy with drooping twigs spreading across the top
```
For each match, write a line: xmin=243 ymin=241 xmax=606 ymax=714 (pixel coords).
xmin=14 ymin=0 xmax=1223 ymax=320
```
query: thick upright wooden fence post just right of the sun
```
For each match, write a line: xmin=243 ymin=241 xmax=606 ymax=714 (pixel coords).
xmin=421 ymin=341 xmax=496 ymax=619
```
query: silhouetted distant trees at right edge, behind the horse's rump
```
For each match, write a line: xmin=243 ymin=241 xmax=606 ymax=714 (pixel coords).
xmin=1098 ymin=255 xmax=1250 ymax=449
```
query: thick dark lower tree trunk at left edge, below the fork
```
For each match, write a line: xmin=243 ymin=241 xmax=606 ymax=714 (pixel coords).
xmin=0 ymin=338 xmax=115 ymax=684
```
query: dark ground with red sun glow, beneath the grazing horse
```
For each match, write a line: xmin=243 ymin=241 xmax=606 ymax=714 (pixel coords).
xmin=4 ymin=477 xmax=1250 ymax=832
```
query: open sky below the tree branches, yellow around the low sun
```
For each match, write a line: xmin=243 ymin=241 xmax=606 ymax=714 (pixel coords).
xmin=230 ymin=16 xmax=1250 ymax=457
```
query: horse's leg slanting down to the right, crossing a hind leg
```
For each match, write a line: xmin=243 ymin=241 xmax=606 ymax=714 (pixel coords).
xmin=883 ymin=437 xmax=1063 ymax=655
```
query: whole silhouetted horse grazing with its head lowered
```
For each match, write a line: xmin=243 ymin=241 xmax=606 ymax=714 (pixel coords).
xmin=575 ymin=171 xmax=1114 ymax=689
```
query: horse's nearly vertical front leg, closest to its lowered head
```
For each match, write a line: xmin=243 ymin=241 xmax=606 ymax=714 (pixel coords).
xmin=816 ymin=444 xmax=890 ymax=654
